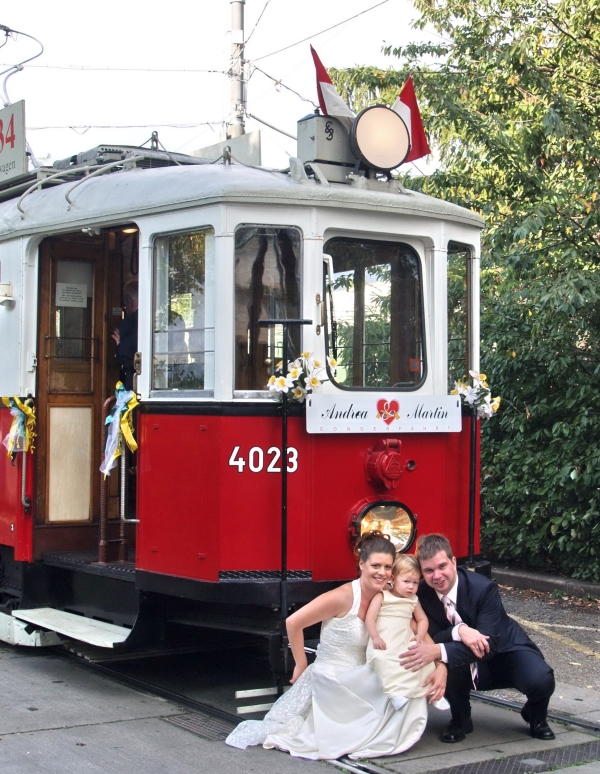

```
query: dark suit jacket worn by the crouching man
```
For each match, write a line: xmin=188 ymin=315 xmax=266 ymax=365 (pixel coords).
xmin=417 ymin=567 xmax=539 ymax=668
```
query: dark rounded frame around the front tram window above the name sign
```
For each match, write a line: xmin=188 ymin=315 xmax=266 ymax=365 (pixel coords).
xmin=323 ymin=235 xmax=428 ymax=392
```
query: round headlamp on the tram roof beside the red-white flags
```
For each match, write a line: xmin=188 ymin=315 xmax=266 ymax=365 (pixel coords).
xmin=350 ymin=105 xmax=410 ymax=172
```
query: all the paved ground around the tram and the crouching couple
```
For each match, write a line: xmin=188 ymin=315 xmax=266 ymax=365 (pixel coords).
xmin=0 ymin=568 xmax=600 ymax=774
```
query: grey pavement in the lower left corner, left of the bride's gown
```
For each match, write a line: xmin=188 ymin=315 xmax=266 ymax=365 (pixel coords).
xmin=0 ymin=646 xmax=324 ymax=774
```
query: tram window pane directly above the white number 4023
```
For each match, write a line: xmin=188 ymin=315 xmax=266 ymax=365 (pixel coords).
xmin=235 ymin=226 xmax=302 ymax=392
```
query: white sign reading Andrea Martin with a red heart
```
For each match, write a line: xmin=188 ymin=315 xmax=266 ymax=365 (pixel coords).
xmin=306 ymin=392 xmax=461 ymax=435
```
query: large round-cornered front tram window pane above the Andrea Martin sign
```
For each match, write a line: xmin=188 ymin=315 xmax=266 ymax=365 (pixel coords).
xmin=325 ymin=238 xmax=426 ymax=390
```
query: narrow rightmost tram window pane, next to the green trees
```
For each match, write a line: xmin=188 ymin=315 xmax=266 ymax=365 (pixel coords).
xmin=448 ymin=242 xmax=471 ymax=390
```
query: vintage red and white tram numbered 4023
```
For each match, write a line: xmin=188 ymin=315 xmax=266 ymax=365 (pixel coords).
xmin=0 ymin=110 xmax=483 ymax=672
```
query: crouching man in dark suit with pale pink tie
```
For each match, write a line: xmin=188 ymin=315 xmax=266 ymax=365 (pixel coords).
xmin=400 ymin=534 xmax=554 ymax=742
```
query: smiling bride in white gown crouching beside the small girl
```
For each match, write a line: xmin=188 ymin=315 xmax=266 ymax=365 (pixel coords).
xmin=227 ymin=532 xmax=446 ymax=760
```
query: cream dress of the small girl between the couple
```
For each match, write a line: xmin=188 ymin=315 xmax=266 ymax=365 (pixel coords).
xmin=367 ymin=590 xmax=435 ymax=699
